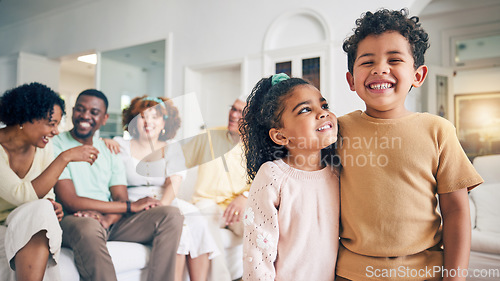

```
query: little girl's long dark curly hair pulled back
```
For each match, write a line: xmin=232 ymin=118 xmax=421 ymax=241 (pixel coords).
xmin=239 ymin=76 xmax=310 ymax=181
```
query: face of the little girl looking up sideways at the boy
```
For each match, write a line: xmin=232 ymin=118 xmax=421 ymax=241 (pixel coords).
xmin=269 ymin=84 xmax=337 ymax=155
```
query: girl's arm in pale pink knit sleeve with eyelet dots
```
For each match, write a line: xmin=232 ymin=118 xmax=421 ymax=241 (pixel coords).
xmin=243 ymin=164 xmax=280 ymax=281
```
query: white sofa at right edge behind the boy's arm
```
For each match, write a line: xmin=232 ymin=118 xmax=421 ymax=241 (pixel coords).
xmin=467 ymin=155 xmax=500 ymax=281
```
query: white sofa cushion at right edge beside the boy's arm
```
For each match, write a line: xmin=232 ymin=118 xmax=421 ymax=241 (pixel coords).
xmin=470 ymin=183 xmax=500 ymax=233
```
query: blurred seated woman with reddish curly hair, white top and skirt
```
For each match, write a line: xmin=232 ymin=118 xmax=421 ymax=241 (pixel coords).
xmin=105 ymin=96 xmax=219 ymax=281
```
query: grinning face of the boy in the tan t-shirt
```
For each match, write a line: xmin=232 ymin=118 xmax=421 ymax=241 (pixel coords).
xmin=346 ymin=31 xmax=427 ymax=119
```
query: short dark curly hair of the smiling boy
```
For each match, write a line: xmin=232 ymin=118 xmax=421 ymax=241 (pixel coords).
xmin=342 ymin=9 xmax=429 ymax=73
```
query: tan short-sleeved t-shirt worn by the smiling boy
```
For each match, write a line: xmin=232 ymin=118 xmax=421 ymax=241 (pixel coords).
xmin=337 ymin=111 xmax=482 ymax=280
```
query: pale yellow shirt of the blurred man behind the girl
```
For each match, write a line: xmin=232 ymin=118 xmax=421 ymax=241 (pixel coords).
xmin=182 ymin=127 xmax=250 ymax=209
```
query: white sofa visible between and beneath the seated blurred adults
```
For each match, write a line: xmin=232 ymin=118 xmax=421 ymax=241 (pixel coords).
xmin=59 ymin=168 xmax=243 ymax=281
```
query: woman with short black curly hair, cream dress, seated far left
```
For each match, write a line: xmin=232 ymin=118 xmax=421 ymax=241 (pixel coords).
xmin=0 ymin=83 xmax=99 ymax=280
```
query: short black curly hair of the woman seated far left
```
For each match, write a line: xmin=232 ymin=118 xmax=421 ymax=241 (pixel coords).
xmin=0 ymin=82 xmax=66 ymax=126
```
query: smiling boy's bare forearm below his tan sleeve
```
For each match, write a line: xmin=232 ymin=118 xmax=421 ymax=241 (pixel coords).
xmin=439 ymin=188 xmax=471 ymax=281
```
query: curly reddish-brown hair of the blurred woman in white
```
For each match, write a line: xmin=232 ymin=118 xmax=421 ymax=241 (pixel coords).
xmin=122 ymin=96 xmax=181 ymax=141
